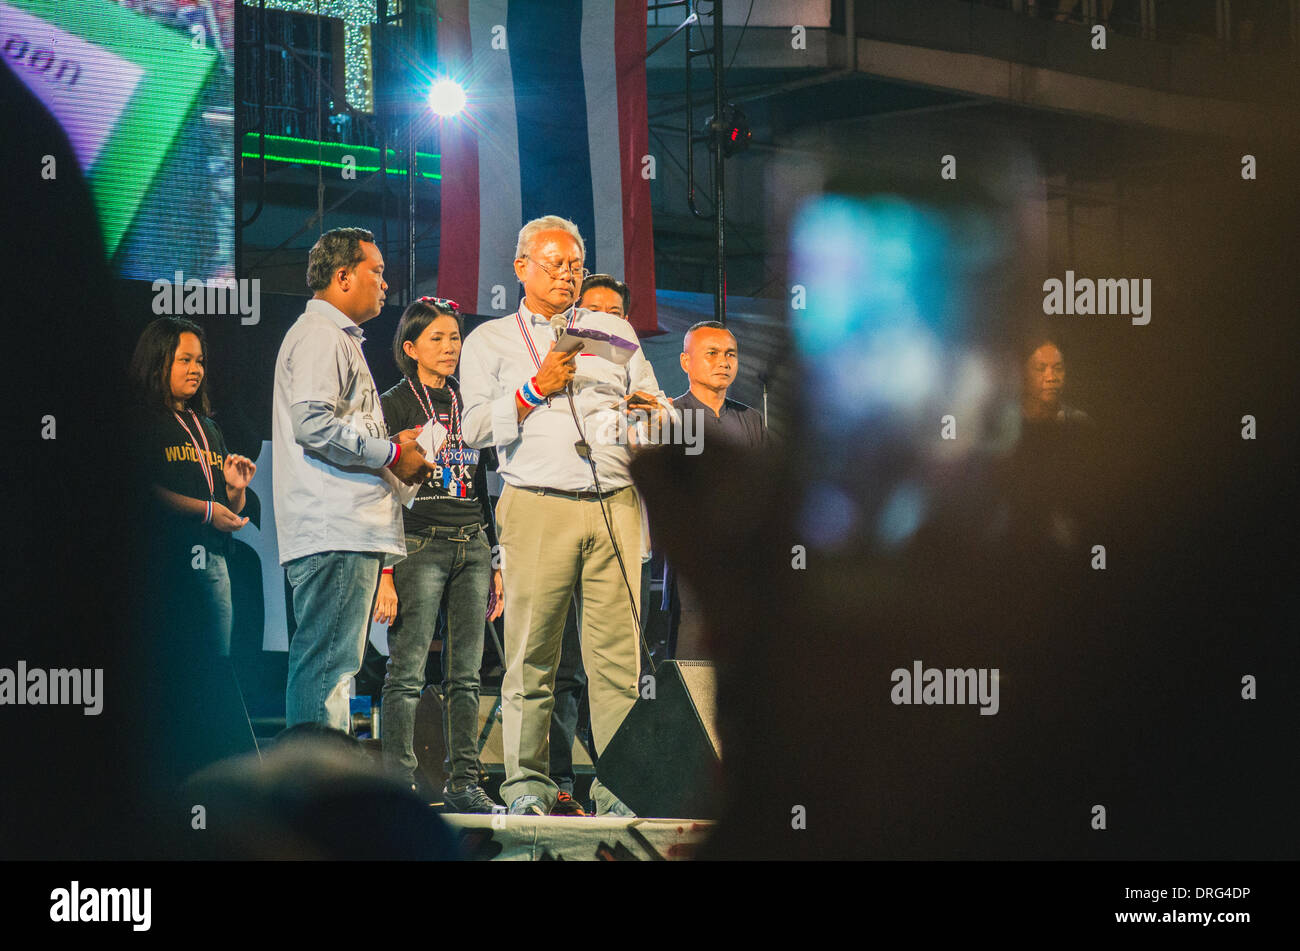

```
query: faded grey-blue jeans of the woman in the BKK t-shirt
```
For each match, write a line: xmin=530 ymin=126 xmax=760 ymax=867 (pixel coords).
xmin=384 ymin=527 xmax=491 ymax=790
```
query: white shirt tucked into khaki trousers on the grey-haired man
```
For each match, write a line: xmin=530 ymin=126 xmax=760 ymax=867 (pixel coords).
xmin=460 ymin=303 xmax=659 ymax=492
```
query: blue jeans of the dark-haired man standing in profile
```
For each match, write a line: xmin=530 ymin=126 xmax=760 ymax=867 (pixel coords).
xmin=285 ymin=551 xmax=384 ymax=733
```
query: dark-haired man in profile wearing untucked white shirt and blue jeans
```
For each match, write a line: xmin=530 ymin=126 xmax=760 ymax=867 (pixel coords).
xmin=272 ymin=227 xmax=432 ymax=731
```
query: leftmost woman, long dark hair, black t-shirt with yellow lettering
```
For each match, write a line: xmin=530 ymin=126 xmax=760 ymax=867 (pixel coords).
xmin=130 ymin=317 xmax=257 ymax=655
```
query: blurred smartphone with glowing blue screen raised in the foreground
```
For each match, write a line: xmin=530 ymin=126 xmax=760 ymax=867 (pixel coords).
xmin=789 ymin=183 xmax=1017 ymax=547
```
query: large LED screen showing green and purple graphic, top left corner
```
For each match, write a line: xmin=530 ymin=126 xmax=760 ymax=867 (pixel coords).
xmin=0 ymin=0 xmax=234 ymax=281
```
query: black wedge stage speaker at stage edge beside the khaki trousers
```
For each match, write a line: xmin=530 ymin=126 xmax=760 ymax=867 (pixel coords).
xmin=595 ymin=660 xmax=720 ymax=818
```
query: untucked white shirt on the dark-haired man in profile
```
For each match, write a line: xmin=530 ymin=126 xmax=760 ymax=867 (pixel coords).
xmin=270 ymin=299 xmax=406 ymax=564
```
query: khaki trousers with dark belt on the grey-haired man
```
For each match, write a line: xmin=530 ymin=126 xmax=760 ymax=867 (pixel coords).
xmin=497 ymin=485 xmax=641 ymax=812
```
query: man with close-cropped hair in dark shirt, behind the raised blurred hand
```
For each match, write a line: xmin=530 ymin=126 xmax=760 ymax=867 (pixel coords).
xmin=664 ymin=321 xmax=767 ymax=660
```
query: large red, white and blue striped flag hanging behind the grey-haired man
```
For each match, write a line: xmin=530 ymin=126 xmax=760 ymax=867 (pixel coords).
xmin=438 ymin=0 xmax=658 ymax=335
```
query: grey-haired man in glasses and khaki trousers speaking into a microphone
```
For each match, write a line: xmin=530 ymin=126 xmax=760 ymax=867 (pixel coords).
xmin=460 ymin=216 xmax=659 ymax=816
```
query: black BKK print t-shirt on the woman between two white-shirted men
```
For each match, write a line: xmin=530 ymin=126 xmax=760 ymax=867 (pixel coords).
xmin=380 ymin=378 xmax=497 ymax=544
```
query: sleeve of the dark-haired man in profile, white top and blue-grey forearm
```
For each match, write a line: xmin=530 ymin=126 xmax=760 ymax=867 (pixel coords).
xmin=286 ymin=336 xmax=394 ymax=469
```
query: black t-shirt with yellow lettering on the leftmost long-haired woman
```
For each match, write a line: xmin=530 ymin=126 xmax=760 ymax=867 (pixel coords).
xmin=133 ymin=412 xmax=230 ymax=557
